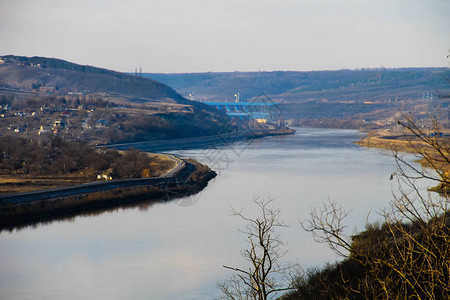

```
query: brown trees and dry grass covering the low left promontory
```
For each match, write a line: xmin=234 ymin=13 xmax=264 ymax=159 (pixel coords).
xmin=0 ymin=136 xmax=175 ymax=193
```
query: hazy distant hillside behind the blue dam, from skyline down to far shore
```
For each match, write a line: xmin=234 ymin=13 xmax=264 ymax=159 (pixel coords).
xmin=144 ymin=68 xmax=450 ymax=128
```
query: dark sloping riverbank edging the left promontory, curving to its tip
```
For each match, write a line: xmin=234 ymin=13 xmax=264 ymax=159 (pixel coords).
xmin=0 ymin=160 xmax=216 ymax=230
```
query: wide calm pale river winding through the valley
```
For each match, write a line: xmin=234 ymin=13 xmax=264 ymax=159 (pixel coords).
xmin=0 ymin=128 xmax=426 ymax=300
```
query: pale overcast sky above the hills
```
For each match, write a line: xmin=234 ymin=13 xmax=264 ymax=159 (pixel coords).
xmin=0 ymin=0 xmax=450 ymax=73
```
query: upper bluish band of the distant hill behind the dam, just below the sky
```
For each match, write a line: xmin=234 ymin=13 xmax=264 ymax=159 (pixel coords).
xmin=143 ymin=68 xmax=450 ymax=103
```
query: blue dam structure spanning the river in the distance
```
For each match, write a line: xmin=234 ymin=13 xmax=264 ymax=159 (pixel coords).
xmin=204 ymin=102 xmax=280 ymax=120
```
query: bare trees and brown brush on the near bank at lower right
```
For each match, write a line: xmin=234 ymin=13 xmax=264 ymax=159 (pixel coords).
xmin=220 ymin=117 xmax=450 ymax=300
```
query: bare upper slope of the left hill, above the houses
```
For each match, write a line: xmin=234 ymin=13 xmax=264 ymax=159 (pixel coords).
xmin=0 ymin=55 xmax=185 ymax=101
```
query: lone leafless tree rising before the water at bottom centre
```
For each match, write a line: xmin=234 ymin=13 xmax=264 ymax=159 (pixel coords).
xmin=219 ymin=198 xmax=298 ymax=300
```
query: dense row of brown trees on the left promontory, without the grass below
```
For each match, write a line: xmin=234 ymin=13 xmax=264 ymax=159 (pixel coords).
xmin=0 ymin=136 xmax=171 ymax=179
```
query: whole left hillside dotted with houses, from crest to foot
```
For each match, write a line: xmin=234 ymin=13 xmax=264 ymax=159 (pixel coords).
xmin=0 ymin=56 xmax=229 ymax=144
